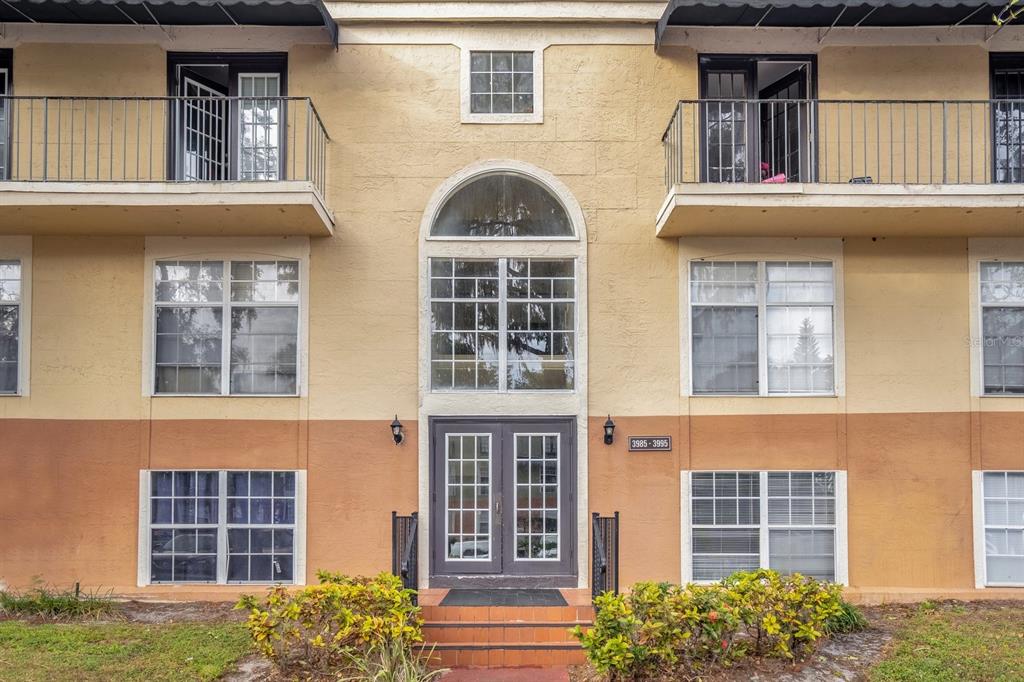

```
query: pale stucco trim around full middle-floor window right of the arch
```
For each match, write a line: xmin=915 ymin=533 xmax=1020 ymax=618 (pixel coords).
xmin=679 ymin=237 xmax=846 ymax=400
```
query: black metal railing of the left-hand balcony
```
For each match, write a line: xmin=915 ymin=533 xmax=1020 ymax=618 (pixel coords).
xmin=0 ymin=96 xmax=330 ymax=197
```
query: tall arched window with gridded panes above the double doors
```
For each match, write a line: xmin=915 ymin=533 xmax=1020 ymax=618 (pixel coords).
xmin=421 ymin=162 xmax=587 ymax=393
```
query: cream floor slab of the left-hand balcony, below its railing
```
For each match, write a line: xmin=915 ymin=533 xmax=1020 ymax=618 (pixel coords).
xmin=0 ymin=180 xmax=334 ymax=237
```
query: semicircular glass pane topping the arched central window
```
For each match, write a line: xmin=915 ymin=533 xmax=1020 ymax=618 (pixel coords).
xmin=430 ymin=172 xmax=574 ymax=239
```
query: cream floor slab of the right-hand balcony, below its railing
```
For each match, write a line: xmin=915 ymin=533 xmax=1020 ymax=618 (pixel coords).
xmin=656 ymin=182 xmax=1024 ymax=238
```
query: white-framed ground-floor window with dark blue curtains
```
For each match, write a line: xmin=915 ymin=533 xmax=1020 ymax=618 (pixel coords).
xmin=139 ymin=470 xmax=305 ymax=585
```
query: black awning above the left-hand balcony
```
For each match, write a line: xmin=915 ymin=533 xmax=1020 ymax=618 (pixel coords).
xmin=0 ymin=0 xmax=338 ymax=45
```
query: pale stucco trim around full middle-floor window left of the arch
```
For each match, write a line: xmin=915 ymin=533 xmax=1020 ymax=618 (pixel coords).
xmin=142 ymin=237 xmax=310 ymax=399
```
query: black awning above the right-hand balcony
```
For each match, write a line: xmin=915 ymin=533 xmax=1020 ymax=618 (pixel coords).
xmin=657 ymin=0 xmax=1006 ymax=43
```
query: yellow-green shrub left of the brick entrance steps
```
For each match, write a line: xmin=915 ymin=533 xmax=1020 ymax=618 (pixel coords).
xmin=238 ymin=571 xmax=422 ymax=679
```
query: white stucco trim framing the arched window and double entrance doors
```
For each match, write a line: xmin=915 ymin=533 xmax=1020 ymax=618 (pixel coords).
xmin=417 ymin=159 xmax=590 ymax=588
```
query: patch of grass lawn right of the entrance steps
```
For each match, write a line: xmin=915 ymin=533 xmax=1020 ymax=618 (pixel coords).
xmin=869 ymin=603 xmax=1024 ymax=682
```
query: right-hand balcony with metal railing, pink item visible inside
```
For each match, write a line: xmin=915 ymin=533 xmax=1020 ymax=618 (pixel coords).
xmin=657 ymin=99 xmax=1024 ymax=238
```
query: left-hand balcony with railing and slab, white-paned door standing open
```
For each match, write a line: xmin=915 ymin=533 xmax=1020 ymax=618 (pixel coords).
xmin=0 ymin=96 xmax=334 ymax=236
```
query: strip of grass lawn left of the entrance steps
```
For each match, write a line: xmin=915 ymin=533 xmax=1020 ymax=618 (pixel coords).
xmin=0 ymin=621 xmax=251 ymax=682
